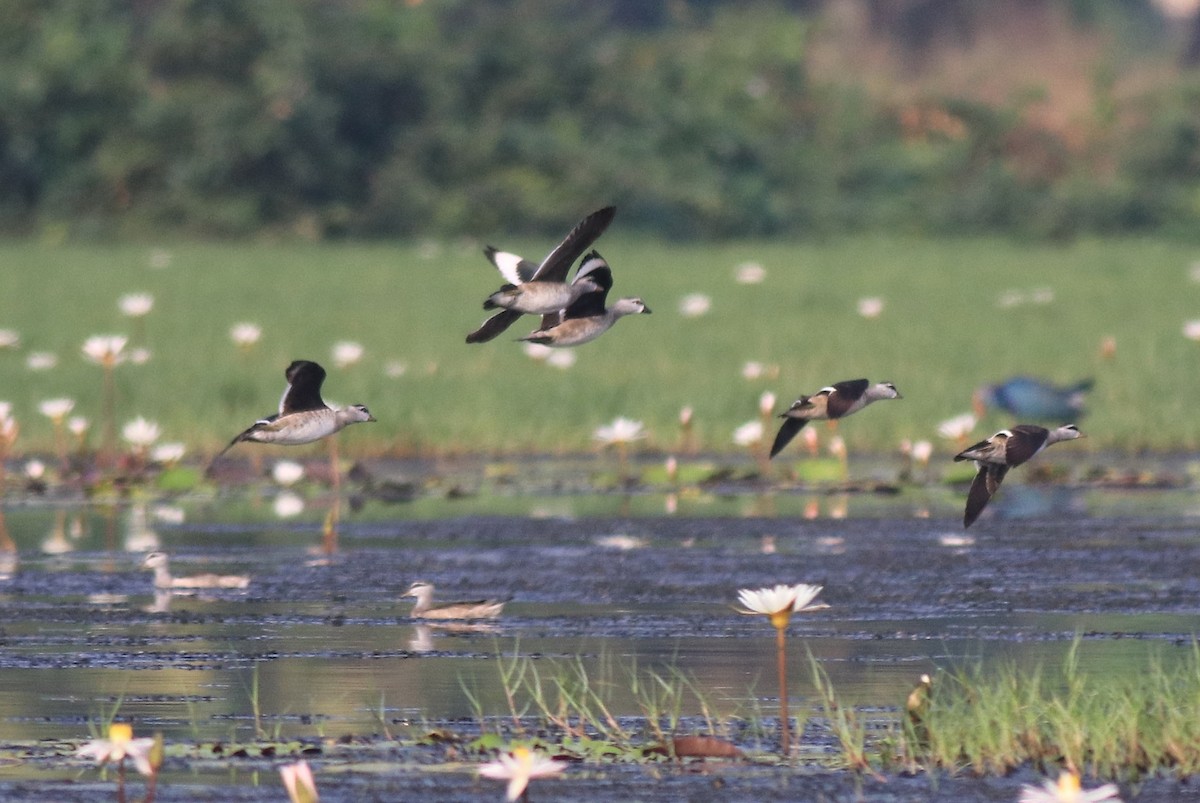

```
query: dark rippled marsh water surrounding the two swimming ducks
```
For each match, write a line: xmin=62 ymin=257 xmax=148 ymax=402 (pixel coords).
xmin=0 ymin=453 xmax=1200 ymax=801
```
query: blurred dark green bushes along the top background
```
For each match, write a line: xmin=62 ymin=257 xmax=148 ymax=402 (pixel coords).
xmin=0 ymin=0 xmax=1200 ymax=239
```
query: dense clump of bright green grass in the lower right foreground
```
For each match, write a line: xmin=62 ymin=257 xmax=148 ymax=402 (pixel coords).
xmin=900 ymin=640 xmax=1200 ymax=779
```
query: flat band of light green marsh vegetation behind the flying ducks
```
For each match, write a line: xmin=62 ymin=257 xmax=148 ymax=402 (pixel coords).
xmin=0 ymin=235 xmax=1200 ymax=456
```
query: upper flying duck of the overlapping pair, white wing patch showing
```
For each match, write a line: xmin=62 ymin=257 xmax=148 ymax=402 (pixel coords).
xmin=467 ymin=206 xmax=617 ymax=343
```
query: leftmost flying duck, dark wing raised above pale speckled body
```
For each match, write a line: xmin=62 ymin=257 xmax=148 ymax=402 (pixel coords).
xmin=212 ymin=360 xmax=376 ymax=462
